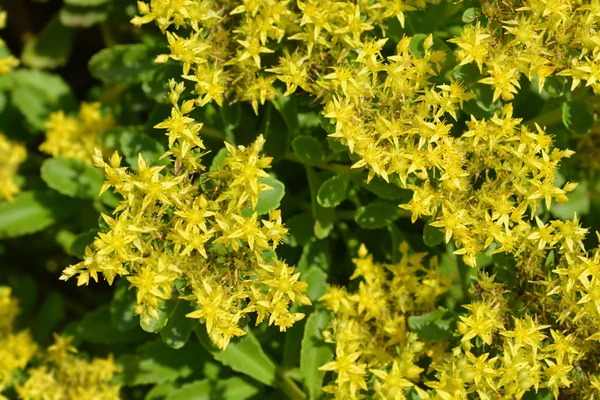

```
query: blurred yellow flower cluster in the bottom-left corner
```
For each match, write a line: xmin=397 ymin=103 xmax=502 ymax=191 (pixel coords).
xmin=0 ymin=287 xmax=120 ymax=400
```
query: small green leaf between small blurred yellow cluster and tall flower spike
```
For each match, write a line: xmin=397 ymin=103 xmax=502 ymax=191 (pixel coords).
xmin=119 ymin=126 xmax=166 ymax=171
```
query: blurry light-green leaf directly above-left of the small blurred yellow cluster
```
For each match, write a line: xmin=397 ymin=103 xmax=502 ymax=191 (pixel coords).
xmin=11 ymin=69 xmax=76 ymax=131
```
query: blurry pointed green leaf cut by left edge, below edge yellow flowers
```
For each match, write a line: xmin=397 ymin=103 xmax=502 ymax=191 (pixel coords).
xmin=0 ymin=191 xmax=80 ymax=239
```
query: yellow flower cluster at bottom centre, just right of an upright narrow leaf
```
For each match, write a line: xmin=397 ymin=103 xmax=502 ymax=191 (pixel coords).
xmin=320 ymin=243 xmax=451 ymax=399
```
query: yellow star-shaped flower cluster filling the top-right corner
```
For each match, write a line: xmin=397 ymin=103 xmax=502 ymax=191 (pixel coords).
xmin=450 ymin=0 xmax=600 ymax=97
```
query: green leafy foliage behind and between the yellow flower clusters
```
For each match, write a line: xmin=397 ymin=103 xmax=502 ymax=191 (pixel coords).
xmin=0 ymin=0 xmax=600 ymax=400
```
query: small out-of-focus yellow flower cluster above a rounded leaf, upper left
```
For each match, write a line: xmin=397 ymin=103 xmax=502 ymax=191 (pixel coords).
xmin=40 ymin=103 xmax=114 ymax=164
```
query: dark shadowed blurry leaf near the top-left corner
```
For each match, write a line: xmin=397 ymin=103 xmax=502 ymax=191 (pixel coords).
xmin=21 ymin=14 xmax=73 ymax=68
